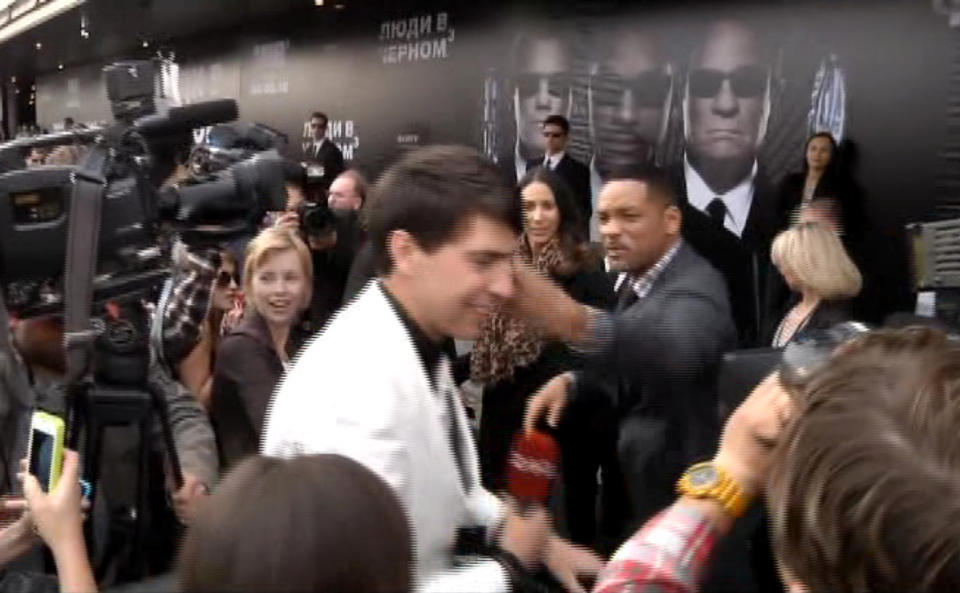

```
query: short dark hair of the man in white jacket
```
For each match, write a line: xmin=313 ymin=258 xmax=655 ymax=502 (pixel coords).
xmin=366 ymin=146 xmax=516 ymax=274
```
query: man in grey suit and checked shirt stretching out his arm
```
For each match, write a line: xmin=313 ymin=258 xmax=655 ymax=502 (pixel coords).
xmin=515 ymin=164 xmax=736 ymax=548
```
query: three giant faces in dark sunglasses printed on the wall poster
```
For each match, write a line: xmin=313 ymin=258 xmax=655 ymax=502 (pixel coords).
xmin=480 ymin=13 xmax=849 ymax=238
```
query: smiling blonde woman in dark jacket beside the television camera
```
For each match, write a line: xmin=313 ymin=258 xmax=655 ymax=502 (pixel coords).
xmin=210 ymin=227 xmax=313 ymax=471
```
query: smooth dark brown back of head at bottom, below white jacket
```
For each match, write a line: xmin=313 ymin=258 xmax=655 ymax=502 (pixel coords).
xmin=178 ymin=455 xmax=413 ymax=593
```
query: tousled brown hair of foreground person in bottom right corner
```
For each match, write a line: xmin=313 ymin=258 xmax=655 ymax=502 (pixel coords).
xmin=767 ymin=327 xmax=960 ymax=593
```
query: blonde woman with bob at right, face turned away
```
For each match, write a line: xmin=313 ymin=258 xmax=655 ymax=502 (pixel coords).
xmin=768 ymin=222 xmax=863 ymax=348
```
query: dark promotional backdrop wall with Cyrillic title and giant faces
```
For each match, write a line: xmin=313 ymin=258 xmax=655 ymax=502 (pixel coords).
xmin=37 ymin=1 xmax=954 ymax=320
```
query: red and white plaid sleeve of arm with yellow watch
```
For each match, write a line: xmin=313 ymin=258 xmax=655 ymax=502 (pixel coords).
xmin=593 ymin=505 xmax=717 ymax=593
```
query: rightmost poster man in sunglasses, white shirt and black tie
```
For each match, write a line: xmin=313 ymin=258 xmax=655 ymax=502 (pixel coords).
xmin=677 ymin=20 xmax=776 ymax=346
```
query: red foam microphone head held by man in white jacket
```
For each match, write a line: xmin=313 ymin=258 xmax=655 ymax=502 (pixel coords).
xmin=507 ymin=431 xmax=560 ymax=511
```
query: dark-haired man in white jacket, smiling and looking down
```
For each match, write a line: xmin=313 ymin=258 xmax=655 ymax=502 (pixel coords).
xmin=263 ymin=146 xmax=600 ymax=592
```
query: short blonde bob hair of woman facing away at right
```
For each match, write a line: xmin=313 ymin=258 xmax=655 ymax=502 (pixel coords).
xmin=770 ymin=222 xmax=863 ymax=300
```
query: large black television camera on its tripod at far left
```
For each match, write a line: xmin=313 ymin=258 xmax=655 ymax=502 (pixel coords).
xmin=0 ymin=61 xmax=286 ymax=578
